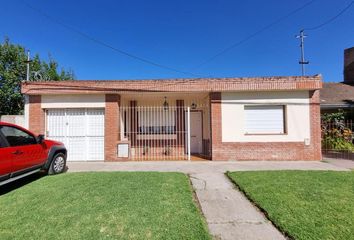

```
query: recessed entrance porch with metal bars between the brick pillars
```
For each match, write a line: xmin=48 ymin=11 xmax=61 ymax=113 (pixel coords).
xmin=118 ymin=93 xmax=210 ymax=161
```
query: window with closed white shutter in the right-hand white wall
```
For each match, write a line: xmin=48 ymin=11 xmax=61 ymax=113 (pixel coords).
xmin=245 ymin=105 xmax=286 ymax=134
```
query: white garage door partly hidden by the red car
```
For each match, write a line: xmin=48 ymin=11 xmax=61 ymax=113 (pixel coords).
xmin=46 ymin=109 xmax=104 ymax=161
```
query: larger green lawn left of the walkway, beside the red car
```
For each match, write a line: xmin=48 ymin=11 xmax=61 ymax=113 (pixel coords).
xmin=0 ymin=172 xmax=210 ymax=239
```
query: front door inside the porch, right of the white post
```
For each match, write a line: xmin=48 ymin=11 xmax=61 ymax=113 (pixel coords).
xmin=190 ymin=112 xmax=203 ymax=153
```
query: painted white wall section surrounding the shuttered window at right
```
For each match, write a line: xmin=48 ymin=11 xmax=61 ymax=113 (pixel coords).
xmin=221 ymin=91 xmax=310 ymax=142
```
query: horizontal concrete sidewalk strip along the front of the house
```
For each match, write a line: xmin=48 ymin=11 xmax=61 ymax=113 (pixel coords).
xmin=67 ymin=161 xmax=347 ymax=174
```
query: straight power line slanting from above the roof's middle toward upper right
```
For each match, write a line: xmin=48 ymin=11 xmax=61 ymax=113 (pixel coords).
xmin=194 ymin=0 xmax=316 ymax=70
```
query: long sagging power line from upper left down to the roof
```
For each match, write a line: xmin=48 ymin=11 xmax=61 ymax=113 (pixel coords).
xmin=19 ymin=0 xmax=201 ymax=77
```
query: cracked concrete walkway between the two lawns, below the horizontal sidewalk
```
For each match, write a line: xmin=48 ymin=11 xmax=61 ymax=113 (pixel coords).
xmin=190 ymin=172 xmax=285 ymax=240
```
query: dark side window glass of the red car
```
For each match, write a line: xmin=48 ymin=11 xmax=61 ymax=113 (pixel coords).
xmin=0 ymin=126 xmax=37 ymax=147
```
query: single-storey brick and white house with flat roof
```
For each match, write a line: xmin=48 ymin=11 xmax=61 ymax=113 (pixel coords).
xmin=22 ymin=75 xmax=322 ymax=161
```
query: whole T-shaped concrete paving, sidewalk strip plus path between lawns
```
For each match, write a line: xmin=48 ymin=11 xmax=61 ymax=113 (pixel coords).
xmin=68 ymin=161 xmax=347 ymax=240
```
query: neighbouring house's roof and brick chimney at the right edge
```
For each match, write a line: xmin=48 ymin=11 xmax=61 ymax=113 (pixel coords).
xmin=321 ymin=47 xmax=354 ymax=119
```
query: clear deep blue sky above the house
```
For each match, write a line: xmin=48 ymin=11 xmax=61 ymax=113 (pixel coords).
xmin=0 ymin=0 xmax=354 ymax=82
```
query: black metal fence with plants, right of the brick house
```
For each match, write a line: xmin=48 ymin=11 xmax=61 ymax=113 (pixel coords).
xmin=321 ymin=120 xmax=354 ymax=160
